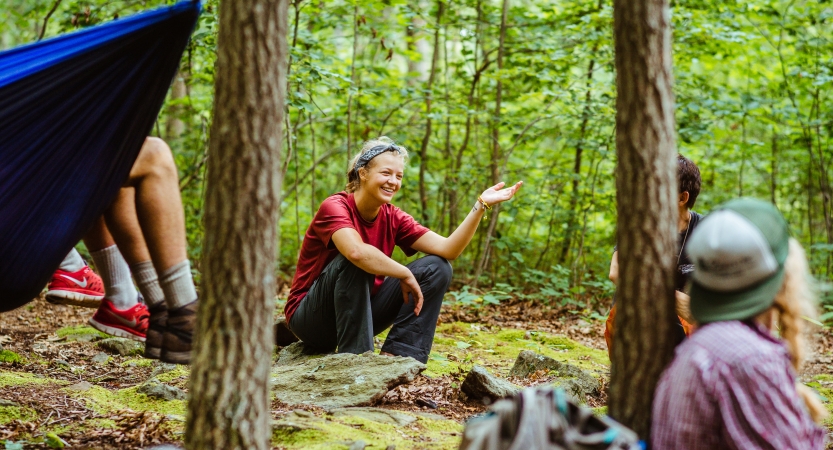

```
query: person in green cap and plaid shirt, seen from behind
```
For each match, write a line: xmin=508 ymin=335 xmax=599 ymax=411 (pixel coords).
xmin=651 ymin=199 xmax=826 ymax=450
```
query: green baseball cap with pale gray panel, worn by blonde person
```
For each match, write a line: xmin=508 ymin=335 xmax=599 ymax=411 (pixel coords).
xmin=686 ymin=198 xmax=790 ymax=324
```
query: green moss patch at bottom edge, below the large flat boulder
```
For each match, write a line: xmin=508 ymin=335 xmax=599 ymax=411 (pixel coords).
xmin=272 ymin=416 xmax=463 ymax=449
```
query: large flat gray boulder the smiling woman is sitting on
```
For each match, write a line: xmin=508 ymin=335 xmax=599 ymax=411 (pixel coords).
xmin=272 ymin=352 xmax=425 ymax=408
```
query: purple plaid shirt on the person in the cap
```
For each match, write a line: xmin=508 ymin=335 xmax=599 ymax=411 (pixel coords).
xmin=651 ymin=321 xmax=825 ymax=450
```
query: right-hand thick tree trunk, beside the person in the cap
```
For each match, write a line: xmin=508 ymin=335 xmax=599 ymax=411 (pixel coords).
xmin=609 ymin=0 xmax=678 ymax=439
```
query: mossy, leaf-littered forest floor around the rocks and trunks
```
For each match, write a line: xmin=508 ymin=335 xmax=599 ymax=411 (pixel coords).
xmin=0 ymin=299 xmax=833 ymax=449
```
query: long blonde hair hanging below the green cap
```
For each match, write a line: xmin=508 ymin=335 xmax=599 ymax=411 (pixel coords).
xmin=772 ymin=238 xmax=828 ymax=423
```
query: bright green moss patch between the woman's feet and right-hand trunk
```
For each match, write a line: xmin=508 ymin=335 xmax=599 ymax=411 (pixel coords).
xmin=425 ymin=323 xmax=610 ymax=376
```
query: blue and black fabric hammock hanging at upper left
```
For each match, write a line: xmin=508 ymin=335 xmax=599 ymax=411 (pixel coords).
xmin=0 ymin=1 xmax=201 ymax=311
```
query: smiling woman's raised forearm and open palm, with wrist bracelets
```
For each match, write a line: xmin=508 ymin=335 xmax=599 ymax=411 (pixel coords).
xmin=411 ymin=181 xmax=523 ymax=260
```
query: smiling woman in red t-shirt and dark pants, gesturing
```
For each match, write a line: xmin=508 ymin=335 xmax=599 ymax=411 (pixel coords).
xmin=285 ymin=137 xmax=522 ymax=363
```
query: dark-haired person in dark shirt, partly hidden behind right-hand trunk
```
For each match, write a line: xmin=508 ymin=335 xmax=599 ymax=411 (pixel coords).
xmin=605 ymin=154 xmax=703 ymax=357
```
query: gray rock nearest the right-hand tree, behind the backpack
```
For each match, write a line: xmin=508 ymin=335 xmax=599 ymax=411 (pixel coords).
xmin=509 ymin=350 xmax=601 ymax=403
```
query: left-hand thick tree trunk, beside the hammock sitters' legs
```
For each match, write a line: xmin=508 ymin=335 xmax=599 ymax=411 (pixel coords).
xmin=185 ymin=0 xmax=288 ymax=449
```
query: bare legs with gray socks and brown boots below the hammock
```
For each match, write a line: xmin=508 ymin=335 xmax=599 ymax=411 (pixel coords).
xmin=105 ymin=138 xmax=197 ymax=364
